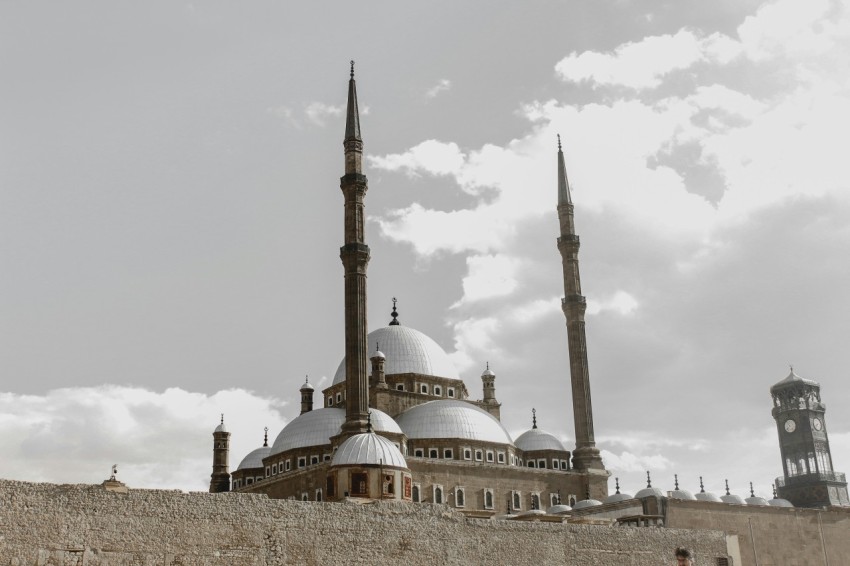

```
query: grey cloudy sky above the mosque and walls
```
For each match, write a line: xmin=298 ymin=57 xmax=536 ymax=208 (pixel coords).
xmin=0 ymin=0 xmax=850 ymax=497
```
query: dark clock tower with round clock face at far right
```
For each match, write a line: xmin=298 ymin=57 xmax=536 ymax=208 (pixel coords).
xmin=770 ymin=368 xmax=850 ymax=507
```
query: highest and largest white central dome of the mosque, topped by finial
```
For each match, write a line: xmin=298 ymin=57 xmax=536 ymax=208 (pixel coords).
xmin=334 ymin=325 xmax=460 ymax=383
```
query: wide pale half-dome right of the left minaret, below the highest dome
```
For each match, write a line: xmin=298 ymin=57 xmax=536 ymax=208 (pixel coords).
xmin=396 ymin=400 xmax=513 ymax=444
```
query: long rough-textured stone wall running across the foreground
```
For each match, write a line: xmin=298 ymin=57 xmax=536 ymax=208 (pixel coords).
xmin=0 ymin=480 xmax=727 ymax=566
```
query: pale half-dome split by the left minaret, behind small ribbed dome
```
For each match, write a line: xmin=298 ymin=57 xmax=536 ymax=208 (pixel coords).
xmin=270 ymin=407 xmax=401 ymax=454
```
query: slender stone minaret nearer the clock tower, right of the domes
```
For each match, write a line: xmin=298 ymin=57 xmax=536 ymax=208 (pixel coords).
xmin=558 ymin=135 xmax=605 ymax=470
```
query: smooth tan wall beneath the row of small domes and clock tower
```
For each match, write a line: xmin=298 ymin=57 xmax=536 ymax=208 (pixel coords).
xmin=666 ymin=499 xmax=850 ymax=566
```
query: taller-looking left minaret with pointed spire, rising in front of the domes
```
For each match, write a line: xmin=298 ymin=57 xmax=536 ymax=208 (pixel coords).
xmin=339 ymin=61 xmax=369 ymax=435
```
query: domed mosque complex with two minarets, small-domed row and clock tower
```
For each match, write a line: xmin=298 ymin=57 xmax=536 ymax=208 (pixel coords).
xmin=204 ymin=62 xmax=850 ymax=518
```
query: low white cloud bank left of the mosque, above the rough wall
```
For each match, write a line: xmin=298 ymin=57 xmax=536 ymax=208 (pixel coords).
xmin=0 ymin=385 xmax=284 ymax=491
